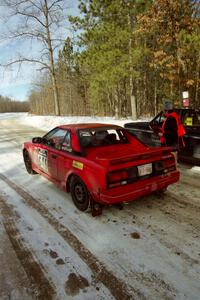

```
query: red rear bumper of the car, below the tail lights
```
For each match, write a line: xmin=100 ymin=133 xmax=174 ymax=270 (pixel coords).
xmin=96 ymin=171 xmax=180 ymax=205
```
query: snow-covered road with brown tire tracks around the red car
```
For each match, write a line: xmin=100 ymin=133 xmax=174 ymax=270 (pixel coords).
xmin=0 ymin=113 xmax=200 ymax=300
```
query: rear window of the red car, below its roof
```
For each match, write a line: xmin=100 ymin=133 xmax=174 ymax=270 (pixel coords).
xmin=79 ymin=127 xmax=129 ymax=148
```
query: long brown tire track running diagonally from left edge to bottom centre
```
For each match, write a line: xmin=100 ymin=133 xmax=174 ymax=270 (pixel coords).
xmin=0 ymin=173 xmax=145 ymax=300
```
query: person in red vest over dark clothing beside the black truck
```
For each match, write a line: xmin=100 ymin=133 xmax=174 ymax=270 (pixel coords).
xmin=160 ymin=109 xmax=185 ymax=151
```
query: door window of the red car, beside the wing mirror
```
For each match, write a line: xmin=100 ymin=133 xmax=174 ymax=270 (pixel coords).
xmin=43 ymin=128 xmax=67 ymax=150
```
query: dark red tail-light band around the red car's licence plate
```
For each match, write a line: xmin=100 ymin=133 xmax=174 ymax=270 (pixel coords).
xmin=107 ymin=158 xmax=176 ymax=188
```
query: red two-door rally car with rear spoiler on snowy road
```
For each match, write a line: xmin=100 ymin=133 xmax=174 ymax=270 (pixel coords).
xmin=23 ymin=123 xmax=179 ymax=212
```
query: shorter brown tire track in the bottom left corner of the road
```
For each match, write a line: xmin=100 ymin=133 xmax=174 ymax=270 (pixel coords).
xmin=0 ymin=197 xmax=55 ymax=300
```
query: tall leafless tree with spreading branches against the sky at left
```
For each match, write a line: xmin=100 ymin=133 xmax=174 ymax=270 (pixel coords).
xmin=1 ymin=0 xmax=66 ymax=115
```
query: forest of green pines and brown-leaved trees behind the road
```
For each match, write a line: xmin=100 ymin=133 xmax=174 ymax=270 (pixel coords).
xmin=0 ymin=0 xmax=200 ymax=119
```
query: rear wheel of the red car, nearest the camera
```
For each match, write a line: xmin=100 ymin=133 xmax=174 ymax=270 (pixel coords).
xmin=70 ymin=176 xmax=91 ymax=211
